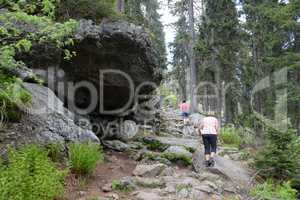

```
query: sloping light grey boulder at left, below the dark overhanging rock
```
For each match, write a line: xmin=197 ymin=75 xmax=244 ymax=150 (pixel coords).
xmin=2 ymin=83 xmax=99 ymax=148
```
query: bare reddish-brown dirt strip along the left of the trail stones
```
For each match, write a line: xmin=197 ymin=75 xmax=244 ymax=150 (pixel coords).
xmin=64 ymin=151 xmax=137 ymax=200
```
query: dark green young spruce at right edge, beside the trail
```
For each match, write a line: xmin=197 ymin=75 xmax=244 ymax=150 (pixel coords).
xmin=255 ymin=127 xmax=300 ymax=181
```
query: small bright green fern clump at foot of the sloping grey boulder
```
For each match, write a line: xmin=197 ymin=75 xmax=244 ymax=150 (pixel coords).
xmin=69 ymin=143 xmax=104 ymax=174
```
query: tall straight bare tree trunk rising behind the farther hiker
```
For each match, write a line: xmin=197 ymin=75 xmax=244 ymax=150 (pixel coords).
xmin=189 ymin=0 xmax=198 ymax=113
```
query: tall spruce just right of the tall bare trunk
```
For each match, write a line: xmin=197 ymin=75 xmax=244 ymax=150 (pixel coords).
xmin=197 ymin=0 xmax=240 ymax=122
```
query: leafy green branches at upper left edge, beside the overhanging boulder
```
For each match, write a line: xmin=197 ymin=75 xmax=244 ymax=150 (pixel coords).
xmin=0 ymin=8 xmax=78 ymax=121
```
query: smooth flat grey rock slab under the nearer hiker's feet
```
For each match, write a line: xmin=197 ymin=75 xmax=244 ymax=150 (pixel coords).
xmin=193 ymin=149 xmax=251 ymax=188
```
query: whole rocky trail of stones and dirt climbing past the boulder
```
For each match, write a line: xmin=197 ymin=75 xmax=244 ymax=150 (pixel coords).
xmin=67 ymin=111 xmax=251 ymax=200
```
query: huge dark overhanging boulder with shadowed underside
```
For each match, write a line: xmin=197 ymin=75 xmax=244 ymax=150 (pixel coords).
xmin=20 ymin=20 xmax=161 ymax=115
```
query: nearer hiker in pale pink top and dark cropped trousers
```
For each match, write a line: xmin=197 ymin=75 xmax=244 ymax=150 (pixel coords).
xmin=199 ymin=116 xmax=220 ymax=167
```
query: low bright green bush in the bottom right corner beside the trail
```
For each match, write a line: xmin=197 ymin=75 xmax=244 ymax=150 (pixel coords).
xmin=250 ymin=180 xmax=297 ymax=200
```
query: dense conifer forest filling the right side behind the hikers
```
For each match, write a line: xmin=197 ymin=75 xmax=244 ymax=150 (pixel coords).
xmin=171 ymin=0 xmax=300 ymax=131
